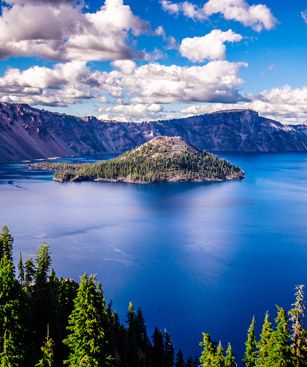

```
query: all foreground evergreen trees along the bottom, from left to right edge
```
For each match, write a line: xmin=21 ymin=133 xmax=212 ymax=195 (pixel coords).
xmin=0 ymin=226 xmax=307 ymax=367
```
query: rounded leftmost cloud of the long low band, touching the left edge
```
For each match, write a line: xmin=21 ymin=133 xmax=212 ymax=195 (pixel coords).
xmin=0 ymin=61 xmax=97 ymax=106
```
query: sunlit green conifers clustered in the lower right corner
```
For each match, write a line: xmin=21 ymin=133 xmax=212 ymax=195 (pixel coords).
xmin=199 ymin=285 xmax=307 ymax=367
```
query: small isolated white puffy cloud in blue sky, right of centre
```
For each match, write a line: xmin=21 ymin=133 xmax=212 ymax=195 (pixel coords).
xmin=179 ymin=29 xmax=242 ymax=62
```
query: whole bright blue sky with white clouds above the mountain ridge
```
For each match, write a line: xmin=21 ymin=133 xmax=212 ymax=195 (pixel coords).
xmin=0 ymin=0 xmax=307 ymax=124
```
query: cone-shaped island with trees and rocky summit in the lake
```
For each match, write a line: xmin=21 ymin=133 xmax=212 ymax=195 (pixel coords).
xmin=35 ymin=136 xmax=244 ymax=183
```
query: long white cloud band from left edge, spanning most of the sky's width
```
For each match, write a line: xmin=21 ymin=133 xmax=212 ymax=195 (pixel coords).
xmin=0 ymin=60 xmax=245 ymax=118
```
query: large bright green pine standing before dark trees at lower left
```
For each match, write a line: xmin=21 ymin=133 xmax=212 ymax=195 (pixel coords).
xmin=64 ymin=274 xmax=111 ymax=367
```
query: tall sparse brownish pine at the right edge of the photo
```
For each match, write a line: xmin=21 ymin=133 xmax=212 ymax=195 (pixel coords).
xmin=289 ymin=285 xmax=307 ymax=367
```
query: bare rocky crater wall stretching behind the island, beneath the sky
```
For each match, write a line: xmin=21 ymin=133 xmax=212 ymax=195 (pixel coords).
xmin=0 ymin=103 xmax=307 ymax=162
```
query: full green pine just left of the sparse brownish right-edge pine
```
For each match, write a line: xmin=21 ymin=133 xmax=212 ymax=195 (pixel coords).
xmin=266 ymin=306 xmax=293 ymax=367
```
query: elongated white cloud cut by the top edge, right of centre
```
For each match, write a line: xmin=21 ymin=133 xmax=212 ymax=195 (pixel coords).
xmin=161 ymin=0 xmax=277 ymax=32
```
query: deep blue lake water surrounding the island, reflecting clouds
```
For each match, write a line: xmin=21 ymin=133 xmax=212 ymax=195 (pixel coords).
xmin=0 ymin=153 xmax=307 ymax=364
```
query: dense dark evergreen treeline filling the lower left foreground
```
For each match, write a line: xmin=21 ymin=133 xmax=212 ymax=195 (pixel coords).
xmin=0 ymin=226 xmax=196 ymax=367
